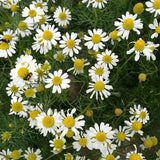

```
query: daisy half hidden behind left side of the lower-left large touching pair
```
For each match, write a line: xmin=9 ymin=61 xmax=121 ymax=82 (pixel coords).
xmin=28 ymin=103 xmax=43 ymax=128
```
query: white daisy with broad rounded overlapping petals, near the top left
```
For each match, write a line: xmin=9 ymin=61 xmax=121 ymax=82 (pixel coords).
xmin=22 ymin=4 xmax=44 ymax=24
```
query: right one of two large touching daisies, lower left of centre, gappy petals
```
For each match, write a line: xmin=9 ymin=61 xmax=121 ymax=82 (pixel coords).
xmin=59 ymin=108 xmax=85 ymax=137
